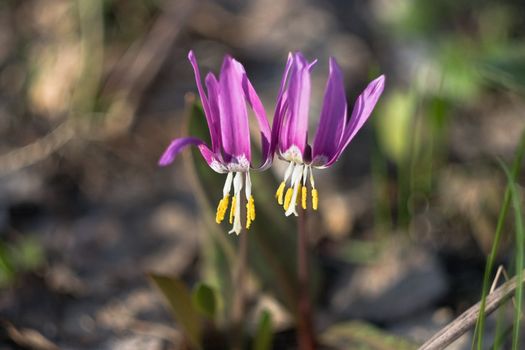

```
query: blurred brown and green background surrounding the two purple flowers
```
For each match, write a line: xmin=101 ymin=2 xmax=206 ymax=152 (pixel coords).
xmin=0 ymin=0 xmax=525 ymax=349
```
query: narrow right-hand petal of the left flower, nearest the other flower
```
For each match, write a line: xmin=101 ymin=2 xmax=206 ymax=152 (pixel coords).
xmin=243 ymin=72 xmax=273 ymax=170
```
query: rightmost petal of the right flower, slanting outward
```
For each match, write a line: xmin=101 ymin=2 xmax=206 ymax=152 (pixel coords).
xmin=325 ymin=75 xmax=385 ymax=166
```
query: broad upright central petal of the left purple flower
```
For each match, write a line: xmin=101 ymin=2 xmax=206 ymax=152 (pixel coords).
xmin=219 ymin=56 xmax=251 ymax=162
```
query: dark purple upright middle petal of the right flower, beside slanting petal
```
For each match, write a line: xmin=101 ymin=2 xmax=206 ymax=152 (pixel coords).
xmin=312 ymin=57 xmax=347 ymax=166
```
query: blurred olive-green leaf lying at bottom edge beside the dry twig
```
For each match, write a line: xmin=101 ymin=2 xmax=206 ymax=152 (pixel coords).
xmin=320 ymin=321 xmax=417 ymax=350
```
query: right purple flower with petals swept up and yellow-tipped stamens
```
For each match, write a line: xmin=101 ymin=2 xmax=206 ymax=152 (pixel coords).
xmin=271 ymin=52 xmax=385 ymax=216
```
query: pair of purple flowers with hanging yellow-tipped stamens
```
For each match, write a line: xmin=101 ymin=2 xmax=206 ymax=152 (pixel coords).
xmin=159 ymin=51 xmax=385 ymax=234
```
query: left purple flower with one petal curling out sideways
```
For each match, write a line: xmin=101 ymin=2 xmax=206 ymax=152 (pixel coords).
xmin=159 ymin=51 xmax=272 ymax=234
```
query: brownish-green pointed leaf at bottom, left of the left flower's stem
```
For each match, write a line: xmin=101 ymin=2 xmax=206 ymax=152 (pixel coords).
xmin=149 ymin=274 xmax=202 ymax=349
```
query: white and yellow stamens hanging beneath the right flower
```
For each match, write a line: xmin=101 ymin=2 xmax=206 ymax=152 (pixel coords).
xmin=275 ymin=162 xmax=319 ymax=216
